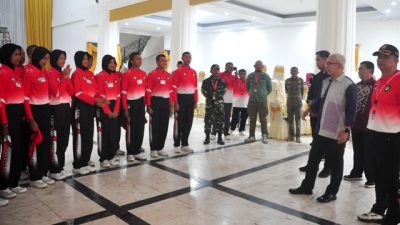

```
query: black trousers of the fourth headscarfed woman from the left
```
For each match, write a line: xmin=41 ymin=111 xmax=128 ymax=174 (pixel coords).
xmin=72 ymin=99 xmax=96 ymax=169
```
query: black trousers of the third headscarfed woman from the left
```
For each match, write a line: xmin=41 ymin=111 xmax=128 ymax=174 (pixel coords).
xmin=50 ymin=103 xmax=71 ymax=173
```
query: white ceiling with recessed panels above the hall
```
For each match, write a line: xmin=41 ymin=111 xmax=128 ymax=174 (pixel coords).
xmin=119 ymin=0 xmax=400 ymax=36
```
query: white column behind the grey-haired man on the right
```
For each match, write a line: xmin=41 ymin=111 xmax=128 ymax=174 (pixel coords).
xmin=316 ymin=0 xmax=357 ymax=80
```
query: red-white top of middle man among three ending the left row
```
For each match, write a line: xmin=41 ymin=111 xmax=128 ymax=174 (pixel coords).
xmin=145 ymin=69 xmax=176 ymax=105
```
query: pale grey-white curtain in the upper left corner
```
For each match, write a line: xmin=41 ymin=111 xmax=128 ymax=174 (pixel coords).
xmin=0 ymin=0 xmax=26 ymax=48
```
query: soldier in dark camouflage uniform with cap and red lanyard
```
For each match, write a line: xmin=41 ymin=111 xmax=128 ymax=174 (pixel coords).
xmin=201 ymin=64 xmax=226 ymax=145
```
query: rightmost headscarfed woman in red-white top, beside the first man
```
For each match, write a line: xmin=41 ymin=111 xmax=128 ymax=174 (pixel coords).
xmin=96 ymin=55 xmax=121 ymax=168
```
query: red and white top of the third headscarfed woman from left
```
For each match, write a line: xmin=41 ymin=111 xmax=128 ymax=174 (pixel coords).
xmin=47 ymin=67 xmax=74 ymax=105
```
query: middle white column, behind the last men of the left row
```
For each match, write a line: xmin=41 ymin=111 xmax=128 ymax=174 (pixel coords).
xmin=171 ymin=0 xmax=197 ymax=68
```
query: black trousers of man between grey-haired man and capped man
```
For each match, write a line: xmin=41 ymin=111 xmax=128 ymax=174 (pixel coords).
xmin=350 ymin=129 xmax=375 ymax=182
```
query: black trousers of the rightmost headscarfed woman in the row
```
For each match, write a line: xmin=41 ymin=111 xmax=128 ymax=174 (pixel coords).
xmin=96 ymin=100 xmax=120 ymax=162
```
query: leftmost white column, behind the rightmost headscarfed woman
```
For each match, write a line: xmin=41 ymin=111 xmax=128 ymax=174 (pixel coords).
xmin=96 ymin=1 xmax=119 ymax=72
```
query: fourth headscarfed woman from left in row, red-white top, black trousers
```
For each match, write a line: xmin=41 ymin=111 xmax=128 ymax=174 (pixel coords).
xmin=71 ymin=51 xmax=106 ymax=175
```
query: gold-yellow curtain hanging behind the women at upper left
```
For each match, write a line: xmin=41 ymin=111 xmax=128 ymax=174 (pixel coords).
xmin=25 ymin=0 xmax=53 ymax=50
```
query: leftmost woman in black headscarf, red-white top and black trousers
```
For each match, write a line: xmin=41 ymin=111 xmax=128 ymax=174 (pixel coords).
xmin=0 ymin=44 xmax=37 ymax=200
